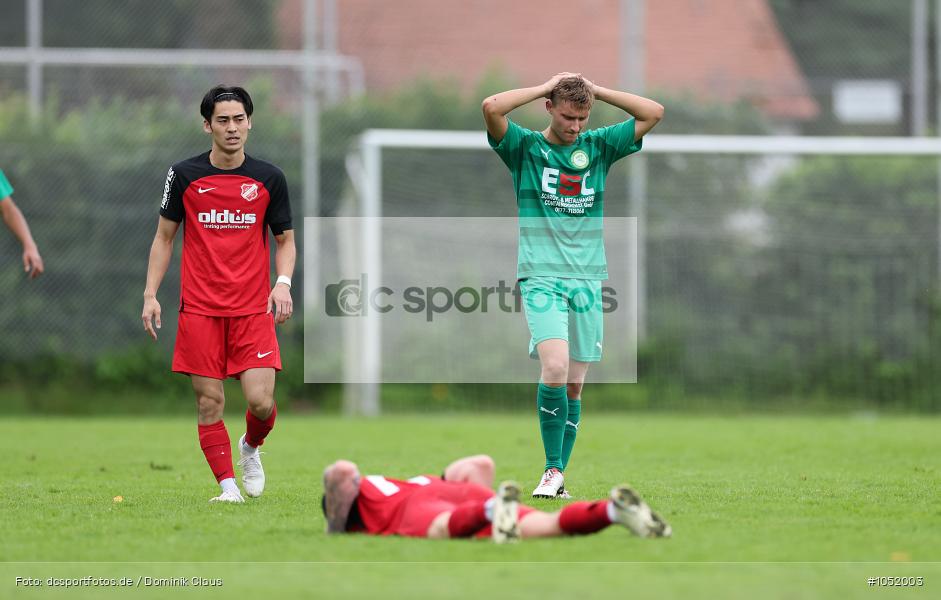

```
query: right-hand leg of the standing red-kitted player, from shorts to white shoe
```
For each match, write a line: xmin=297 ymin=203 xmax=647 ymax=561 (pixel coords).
xmin=239 ymin=368 xmax=277 ymax=498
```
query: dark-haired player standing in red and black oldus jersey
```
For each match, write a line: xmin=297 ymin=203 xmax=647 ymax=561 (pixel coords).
xmin=141 ymin=86 xmax=297 ymax=502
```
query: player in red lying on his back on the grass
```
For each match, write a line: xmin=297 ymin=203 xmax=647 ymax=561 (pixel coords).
xmin=321 ymin=454 xmax=671 ymax=543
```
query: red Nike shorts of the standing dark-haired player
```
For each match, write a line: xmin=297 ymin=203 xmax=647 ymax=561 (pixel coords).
xmin=172 ymin=312 xmax=281 ymax=379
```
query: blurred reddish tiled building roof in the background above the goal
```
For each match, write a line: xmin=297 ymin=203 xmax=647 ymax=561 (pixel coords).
xmin=281 ymin=0 xmax=819 ymax=120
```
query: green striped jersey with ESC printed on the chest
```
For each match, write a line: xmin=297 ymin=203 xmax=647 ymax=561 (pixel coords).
xmin=487 ymin=117 xmax=642 ymax=279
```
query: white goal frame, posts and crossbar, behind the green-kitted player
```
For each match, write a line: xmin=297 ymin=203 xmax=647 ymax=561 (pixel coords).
xmin=344 ymin=129 xmax=941 ymax=416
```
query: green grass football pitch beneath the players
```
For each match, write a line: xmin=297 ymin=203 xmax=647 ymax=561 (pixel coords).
xmin=0 ymin=414 xmax=941 ymax=600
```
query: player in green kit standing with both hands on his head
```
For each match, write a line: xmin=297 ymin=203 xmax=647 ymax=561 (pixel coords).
xmin=482 ymin=73 xmax=663 ymax=498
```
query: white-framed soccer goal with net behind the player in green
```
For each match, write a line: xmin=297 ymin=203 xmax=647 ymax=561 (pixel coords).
xmin=305 ymin=130 xmax=941 ymax=414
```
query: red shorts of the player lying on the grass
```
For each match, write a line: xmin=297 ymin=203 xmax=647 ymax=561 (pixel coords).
xmin=393 ymin=481 xmax=535 ymax=537
